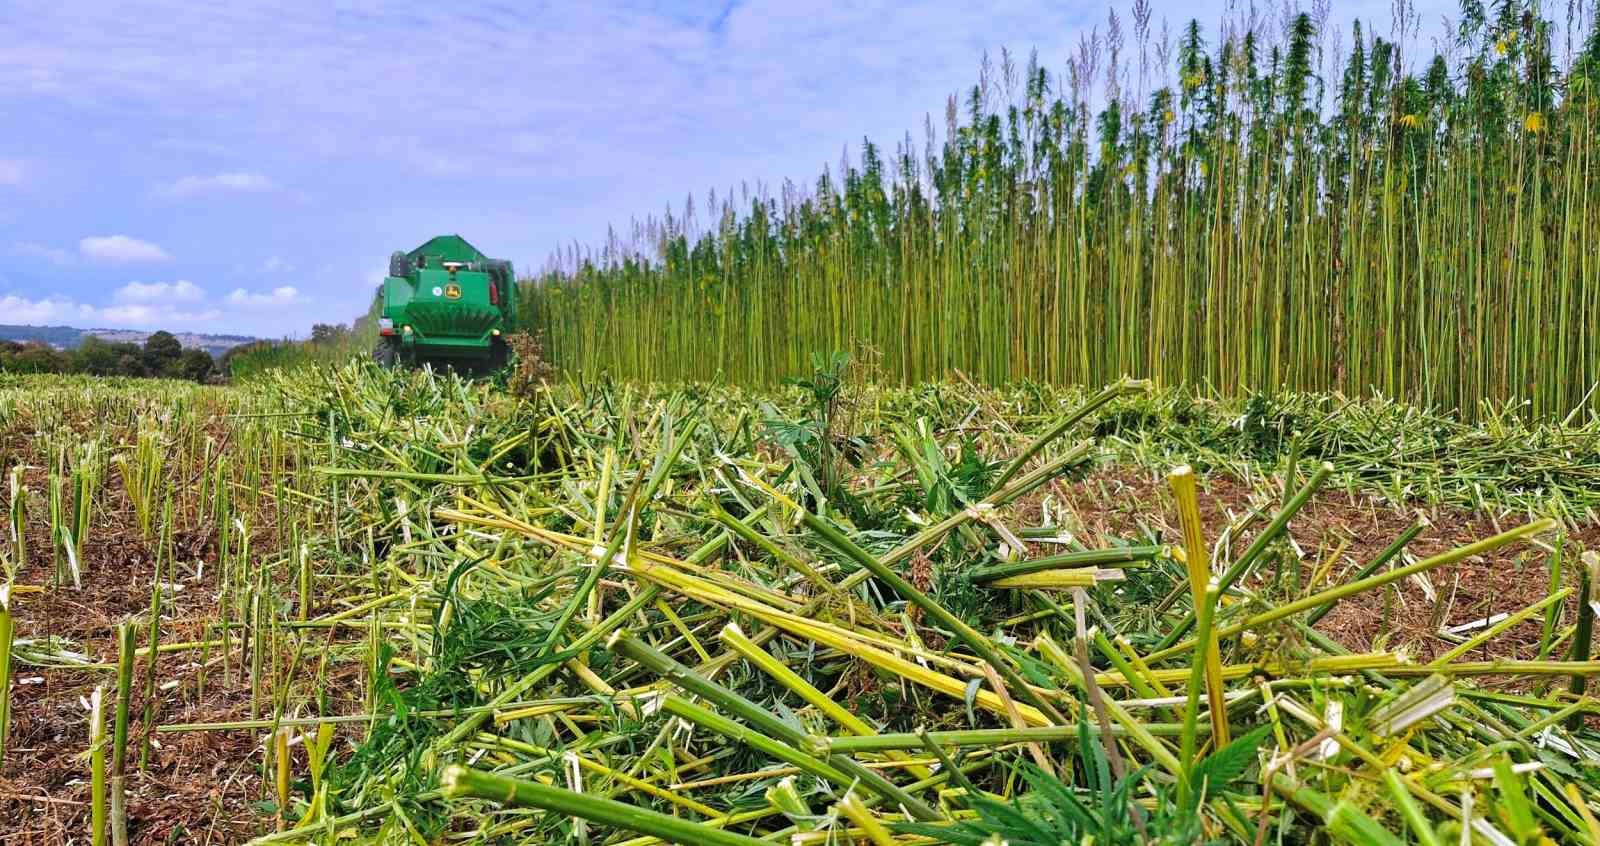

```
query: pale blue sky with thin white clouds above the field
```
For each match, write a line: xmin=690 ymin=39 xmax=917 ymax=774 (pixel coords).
xmin=0 ymin=0 xmax=1453 ymax=336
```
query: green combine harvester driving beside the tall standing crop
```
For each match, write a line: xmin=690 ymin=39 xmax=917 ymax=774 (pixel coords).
xmin=373 ymin=235 xmax=517 ymax=371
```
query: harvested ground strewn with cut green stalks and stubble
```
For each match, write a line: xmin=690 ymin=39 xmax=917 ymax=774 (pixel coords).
xmin=0 ymin=363 xmax=1600 ymax=846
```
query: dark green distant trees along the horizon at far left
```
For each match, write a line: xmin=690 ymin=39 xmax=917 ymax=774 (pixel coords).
xmin=0 ymin=331 xmax=218 ymax=382
